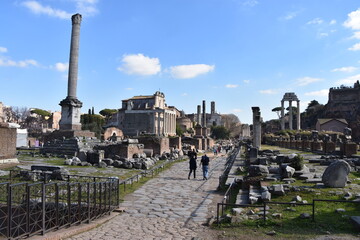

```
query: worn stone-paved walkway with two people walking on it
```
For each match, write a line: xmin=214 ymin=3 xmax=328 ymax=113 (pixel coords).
xmin=69 ymin=156 xmax=226 ymax=240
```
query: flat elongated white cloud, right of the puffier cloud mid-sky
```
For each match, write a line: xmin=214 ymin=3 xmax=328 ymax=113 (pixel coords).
xmin=170 ymin=64 xmax=215 ymax=79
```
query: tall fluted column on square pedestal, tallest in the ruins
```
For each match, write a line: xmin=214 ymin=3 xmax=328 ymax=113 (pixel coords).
xmin=59 ymin=13 xmax=82 ymax=130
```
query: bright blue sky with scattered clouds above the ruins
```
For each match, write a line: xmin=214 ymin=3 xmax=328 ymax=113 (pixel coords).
xmin=0 ymin=0 xmax=360 ymax=123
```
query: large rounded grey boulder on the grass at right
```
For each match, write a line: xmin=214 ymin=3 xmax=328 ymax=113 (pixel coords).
xmin=322 ymin=160 xmax=351 ymax=187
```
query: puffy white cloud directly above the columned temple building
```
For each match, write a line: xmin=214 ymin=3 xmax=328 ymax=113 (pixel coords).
xmin=117 ymin=53 xmax=161 ymax=76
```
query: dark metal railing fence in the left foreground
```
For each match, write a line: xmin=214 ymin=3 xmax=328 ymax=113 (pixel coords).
xmin=0 ymin=172 xmax=119 ymax=239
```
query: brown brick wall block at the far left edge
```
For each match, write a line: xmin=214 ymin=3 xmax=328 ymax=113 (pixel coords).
xmin=0 ymin=123 xmax=16 ymax=160
